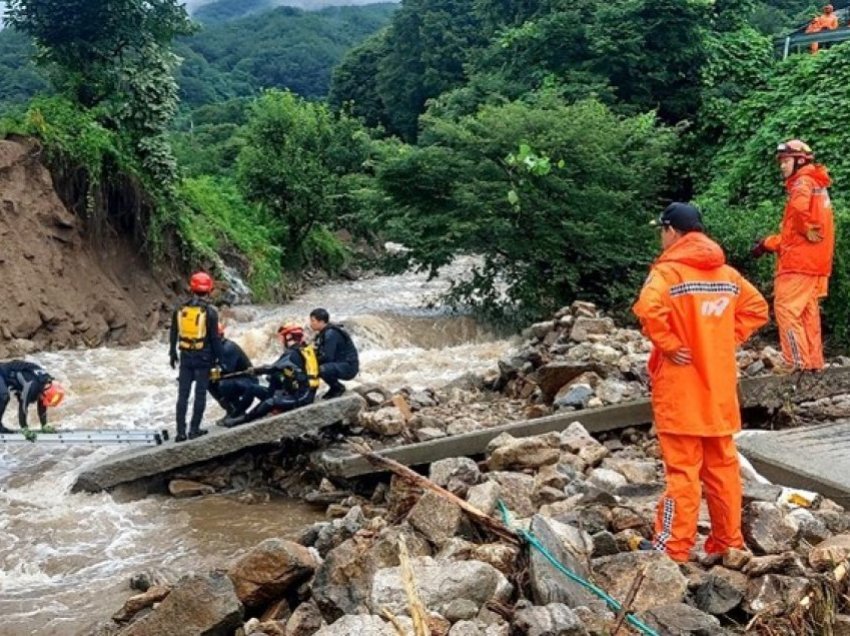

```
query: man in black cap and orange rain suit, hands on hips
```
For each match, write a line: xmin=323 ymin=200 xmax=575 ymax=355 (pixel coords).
xmin=633 ymin=203 xmax=768 ymax=562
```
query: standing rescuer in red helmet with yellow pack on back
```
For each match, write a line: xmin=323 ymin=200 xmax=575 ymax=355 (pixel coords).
xmin=169 ymin=272 xmax=221 ymax=442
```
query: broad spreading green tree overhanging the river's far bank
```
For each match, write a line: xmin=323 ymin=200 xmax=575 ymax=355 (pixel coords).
xmin=378 ymin=95 xmax=674 ymax=324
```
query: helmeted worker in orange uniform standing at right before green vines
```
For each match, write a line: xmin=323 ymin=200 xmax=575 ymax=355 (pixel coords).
xmin=751 ymin=139 xmax=835 ymax=370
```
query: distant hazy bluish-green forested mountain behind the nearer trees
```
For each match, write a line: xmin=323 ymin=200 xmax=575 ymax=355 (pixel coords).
xmin=0 ymin=0 xmax=396 ymax=111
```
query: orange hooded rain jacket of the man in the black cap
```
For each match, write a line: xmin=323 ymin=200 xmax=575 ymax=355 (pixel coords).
xmin=633 ymin=232 xmax=768 ymax=437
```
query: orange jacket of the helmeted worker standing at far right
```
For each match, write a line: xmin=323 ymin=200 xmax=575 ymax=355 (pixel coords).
xmin=764 ymin=163 xmax=835 ymax=276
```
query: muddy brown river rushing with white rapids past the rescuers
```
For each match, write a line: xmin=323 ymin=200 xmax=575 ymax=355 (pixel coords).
xmin=0 ymin=261 xmax=509 ymax=636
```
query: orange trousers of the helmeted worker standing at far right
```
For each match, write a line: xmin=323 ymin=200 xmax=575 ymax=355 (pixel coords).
xmin=773 ymin=274 xmax=827 ymax=370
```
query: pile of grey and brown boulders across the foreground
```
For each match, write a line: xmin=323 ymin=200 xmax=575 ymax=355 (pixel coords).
xmin=102 ymin=423 xmax=850 ymax=636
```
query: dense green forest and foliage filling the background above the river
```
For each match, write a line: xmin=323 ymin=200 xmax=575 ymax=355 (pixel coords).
xmin=0 ymin=0 xmax=850 ymax=346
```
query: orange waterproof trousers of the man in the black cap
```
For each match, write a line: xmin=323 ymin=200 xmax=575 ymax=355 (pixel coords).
xmin=654 ymin=433 xmax=744 ymax=562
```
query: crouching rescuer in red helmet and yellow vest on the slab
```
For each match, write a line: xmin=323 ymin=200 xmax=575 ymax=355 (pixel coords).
xmin=224 ymin=323 xmax=319 ymax=427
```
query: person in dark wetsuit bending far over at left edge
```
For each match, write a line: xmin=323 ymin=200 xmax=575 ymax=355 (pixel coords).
xmin=0 ymin=360 xmax=65 ymax=433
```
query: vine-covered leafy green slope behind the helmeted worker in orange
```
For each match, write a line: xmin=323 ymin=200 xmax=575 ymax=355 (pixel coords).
xmin=698 ymin=44 xmax=850 ymax=349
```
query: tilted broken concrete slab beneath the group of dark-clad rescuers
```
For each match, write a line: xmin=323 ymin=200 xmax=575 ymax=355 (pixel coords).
xmin=72 ymin=395 xmax=365 ymax=492
